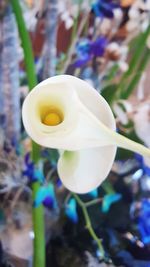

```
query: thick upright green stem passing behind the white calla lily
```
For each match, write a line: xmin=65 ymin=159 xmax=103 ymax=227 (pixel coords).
xmin=10 ymin=0 xmax=45 ymax=267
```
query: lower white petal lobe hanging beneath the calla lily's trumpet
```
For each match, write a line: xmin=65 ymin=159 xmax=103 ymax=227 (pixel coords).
xmin=58 ymin=146 xmax=116 ymax=194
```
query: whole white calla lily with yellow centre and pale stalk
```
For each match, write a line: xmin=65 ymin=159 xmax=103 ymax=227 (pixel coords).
xmin=22 ymin=75 xmax=150 ymax=193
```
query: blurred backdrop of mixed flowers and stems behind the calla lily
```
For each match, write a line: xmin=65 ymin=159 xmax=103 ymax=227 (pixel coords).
xmin=0 ymin=0 xmax=150 ymax=267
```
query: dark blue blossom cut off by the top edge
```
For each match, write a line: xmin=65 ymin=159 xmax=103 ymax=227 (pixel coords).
xmin=92 ymin=0 xmax=120 ymax=19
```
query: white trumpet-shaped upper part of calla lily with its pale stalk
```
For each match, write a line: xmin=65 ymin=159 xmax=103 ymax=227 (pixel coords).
xmin=23 ymin=75 xmax=150 ymax=156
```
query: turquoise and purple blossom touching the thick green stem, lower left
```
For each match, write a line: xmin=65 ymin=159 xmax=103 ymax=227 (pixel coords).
xmin=33 ymin=183 xmax=58 ymax=209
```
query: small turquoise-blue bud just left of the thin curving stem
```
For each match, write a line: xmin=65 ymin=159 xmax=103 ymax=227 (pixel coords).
xmin=65 ymin=198 xmax=78 ymax=223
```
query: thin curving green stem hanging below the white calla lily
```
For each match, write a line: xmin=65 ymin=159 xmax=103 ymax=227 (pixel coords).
xmin=72 ymin=193 xmax=104 ymax=258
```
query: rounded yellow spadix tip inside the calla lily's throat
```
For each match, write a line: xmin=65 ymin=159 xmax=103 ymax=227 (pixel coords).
xmin=43 ymin=112 xmax=62 ymax=126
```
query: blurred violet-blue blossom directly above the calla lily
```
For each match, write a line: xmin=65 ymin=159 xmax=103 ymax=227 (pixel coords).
xmin=73 ymin=36 xmax=108 ymax=68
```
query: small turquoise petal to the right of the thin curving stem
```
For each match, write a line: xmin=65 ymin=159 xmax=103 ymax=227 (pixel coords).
xmin=102 ymin=193 xmax=122 ymax=213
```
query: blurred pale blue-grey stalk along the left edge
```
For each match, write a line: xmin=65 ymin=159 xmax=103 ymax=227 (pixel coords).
xmin=0 ymin=5 xmax=21 ymax=145
